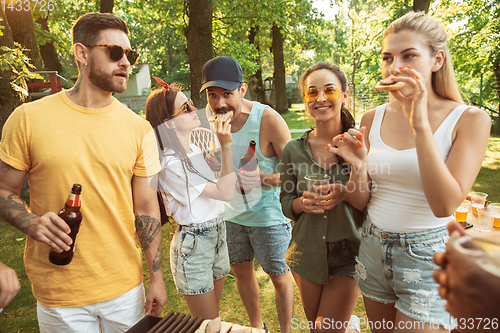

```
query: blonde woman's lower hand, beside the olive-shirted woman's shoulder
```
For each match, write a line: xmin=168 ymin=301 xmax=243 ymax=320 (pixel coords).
xmin=327 ymin=126 xmax=368 ymax=168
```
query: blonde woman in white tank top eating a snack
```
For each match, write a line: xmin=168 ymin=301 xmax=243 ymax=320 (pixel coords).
xmin=330 ymin=12 xmax=491 ymax=333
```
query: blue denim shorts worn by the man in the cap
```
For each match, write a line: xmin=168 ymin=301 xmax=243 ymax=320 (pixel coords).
xmin=227 ymin=221 xmax=292 ymax=275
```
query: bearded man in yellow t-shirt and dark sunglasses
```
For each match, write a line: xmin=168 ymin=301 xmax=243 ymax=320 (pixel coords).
xmin=0 ymin=13 xmax=167 ymax=333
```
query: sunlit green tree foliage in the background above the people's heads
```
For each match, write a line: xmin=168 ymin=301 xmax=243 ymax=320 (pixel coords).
xmin=18 ymin=0 xmax=500 ymax=120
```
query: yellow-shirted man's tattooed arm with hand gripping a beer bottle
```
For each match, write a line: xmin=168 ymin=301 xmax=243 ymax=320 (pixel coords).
xmin=0 ymin=161 xmax=72 ymax=252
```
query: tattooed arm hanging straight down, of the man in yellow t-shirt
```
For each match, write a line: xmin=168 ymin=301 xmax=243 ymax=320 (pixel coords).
xmin=132 ymin=176 xmax=167 ymax=316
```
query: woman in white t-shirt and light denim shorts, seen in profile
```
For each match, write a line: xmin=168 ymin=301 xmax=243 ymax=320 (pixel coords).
xmin=146 ymin=78 xmax=234 ymax=318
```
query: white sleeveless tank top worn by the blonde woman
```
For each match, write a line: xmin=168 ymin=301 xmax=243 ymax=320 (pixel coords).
xmin=367 ymin=104 xmax=469 ymax=232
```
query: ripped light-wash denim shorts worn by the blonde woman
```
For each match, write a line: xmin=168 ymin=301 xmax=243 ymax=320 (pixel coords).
xmin=355 ymin=216 xmax=455 ymax=329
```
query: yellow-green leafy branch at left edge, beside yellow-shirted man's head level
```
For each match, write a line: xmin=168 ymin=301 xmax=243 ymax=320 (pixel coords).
xmin=0 ymin=42 xmax=42 ymax=96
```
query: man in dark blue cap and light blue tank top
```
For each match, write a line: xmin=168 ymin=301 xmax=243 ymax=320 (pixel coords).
xmin=200 ymin=56 xmax=293 ymax=333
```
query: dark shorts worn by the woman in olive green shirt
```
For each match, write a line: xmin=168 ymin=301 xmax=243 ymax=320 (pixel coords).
xmin=326 ymin=239 xmax=356 ymax=278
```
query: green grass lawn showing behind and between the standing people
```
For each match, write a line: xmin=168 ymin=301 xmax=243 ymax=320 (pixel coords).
xmin=0 ymin=104 xmax=500 ymax=333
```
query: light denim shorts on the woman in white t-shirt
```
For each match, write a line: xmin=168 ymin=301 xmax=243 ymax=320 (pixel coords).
xmin=170 ymin=215 xmax=230 ymax=295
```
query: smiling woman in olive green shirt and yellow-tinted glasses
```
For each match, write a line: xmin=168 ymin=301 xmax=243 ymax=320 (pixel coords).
xmin=280 ymin=62 xmax=362 ymax=332
